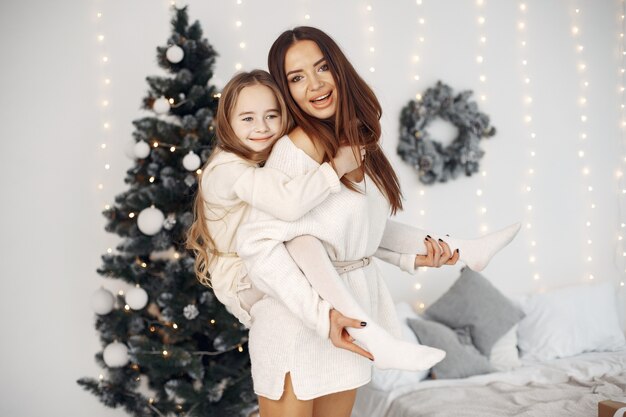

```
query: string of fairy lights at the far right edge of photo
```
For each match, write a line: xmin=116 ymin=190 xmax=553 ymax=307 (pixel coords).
xmin=615 ymin=0 xmax=626 ymax=289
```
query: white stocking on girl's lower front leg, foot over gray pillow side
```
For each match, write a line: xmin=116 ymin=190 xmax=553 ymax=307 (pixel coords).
xmin=285 ymin=236 xmax=446 ymax=371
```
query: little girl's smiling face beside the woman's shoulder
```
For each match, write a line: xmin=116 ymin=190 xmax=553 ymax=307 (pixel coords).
xmin=230 ymin=84 xmax=282 ymax=152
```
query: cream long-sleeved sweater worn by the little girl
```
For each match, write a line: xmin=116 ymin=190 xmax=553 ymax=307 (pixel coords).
xmin=200 ymin=145 xmax=340 ymax=327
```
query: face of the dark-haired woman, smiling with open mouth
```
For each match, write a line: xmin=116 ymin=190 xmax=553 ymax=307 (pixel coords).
xmin=285 ymin=40 xmax=339 ymax=119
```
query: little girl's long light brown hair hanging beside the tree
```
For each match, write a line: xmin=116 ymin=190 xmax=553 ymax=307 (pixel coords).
xmin=186 ymin=70 xmax=292 ymax=287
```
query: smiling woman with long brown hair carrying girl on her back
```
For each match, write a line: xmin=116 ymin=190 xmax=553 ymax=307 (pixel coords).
xmin=237 ymin=27 xmax=459 ymax=417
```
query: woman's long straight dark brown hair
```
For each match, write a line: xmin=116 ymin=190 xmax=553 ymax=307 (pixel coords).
xmin=268 ymin=26 xmax=402 ymax=214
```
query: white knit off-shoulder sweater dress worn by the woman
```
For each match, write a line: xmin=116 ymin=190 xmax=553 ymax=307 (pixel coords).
xmin=237 ymin=137 xmax=415 ymax=400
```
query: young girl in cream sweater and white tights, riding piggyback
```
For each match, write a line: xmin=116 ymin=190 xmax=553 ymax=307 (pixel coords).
xmin=188 ymin=70 xmax=516 ymax=370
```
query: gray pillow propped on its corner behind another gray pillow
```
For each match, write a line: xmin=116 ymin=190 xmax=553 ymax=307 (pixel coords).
xmin=425 ymin=268 xmax=524 ymax=356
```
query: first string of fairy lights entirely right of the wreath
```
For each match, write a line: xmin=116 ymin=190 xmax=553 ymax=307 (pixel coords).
xmin=516 ymin=2 xmax=541 ymax=281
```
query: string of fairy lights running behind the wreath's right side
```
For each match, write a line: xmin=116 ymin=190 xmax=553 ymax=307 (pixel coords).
xmin=475 ymin=0 xmax=489 ymax=234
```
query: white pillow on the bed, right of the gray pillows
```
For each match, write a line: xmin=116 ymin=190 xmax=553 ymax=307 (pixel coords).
xmin=518 ymin=282 xmax=626 ymax=360
